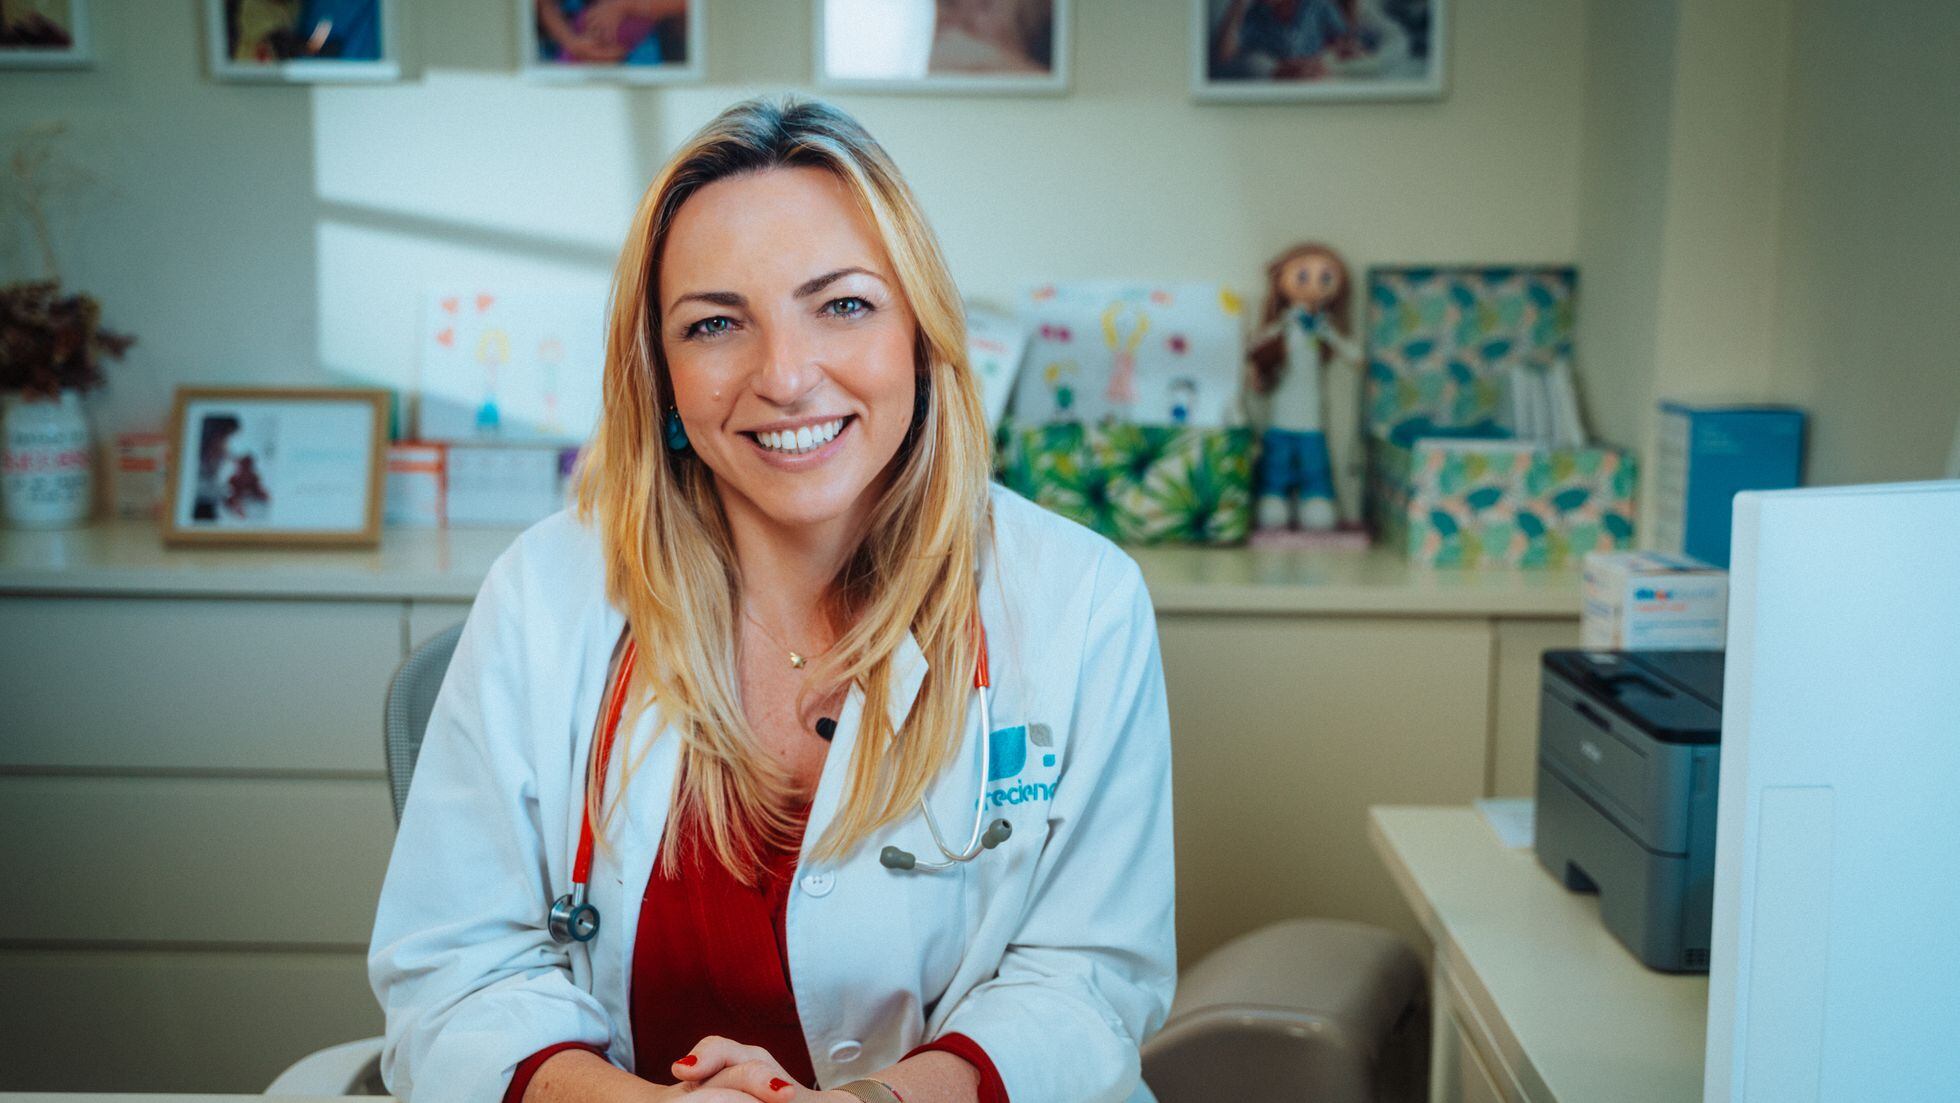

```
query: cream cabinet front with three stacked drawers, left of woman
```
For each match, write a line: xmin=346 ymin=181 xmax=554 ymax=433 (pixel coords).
xmin=0 ymin=594 xmax=406 ymax=1091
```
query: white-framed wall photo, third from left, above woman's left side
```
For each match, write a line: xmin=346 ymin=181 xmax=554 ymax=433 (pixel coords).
xmin=517 ymin=0 xmax=702 ymax=84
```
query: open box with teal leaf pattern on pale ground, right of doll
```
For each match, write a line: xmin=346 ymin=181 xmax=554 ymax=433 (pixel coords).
xmin=1368 ymin=437 xmax=1637 ymax=568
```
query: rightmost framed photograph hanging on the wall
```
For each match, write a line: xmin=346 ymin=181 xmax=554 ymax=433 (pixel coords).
xmin=1192 ymin=0 xmax=1450 ymax=102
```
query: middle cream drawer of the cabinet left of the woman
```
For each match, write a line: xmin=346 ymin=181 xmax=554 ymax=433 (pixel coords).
xmin=0 ymin=776 xmax=394 ymax=948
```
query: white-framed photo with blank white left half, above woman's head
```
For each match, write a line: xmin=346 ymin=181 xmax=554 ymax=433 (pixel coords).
xmin=815 ymin=0 xmax=1068 ymax=94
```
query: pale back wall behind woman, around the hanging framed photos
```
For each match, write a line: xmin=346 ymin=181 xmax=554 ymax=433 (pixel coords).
xmin=0 ymin=0 xmax=1586 ymax=444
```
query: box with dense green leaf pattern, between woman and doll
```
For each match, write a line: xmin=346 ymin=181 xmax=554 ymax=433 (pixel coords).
xmin=1000 ymin=423 xmax=1252 ymax=545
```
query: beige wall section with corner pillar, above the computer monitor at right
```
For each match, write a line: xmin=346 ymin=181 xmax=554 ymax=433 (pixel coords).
xmin=1578 ymin=0 xmax=1960 ymax=495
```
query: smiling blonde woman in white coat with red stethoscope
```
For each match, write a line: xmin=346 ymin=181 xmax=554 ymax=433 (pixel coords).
xmin=368 ymin=100 xmax=1174 ymax=1103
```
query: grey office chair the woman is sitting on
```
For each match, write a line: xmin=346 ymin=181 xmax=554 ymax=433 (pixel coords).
xmin=265 ymin=625 xmax=463 ymax=1095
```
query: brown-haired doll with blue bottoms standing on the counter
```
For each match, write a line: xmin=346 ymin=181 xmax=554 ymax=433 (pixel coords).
xmin=1249 ymin=243 xmax=1360 ymax=531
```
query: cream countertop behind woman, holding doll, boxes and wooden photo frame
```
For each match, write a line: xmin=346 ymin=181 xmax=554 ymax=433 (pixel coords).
xmin=0 ymin=521 xmax=1580 ymax=617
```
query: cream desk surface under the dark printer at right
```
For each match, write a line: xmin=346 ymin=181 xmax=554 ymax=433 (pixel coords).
xmin=1368 ymin=807 xmax=1709 ymax=1103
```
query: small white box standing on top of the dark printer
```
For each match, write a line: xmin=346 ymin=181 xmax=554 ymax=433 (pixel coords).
xmin=1580 ymin=552 xmax=1729 ymax=650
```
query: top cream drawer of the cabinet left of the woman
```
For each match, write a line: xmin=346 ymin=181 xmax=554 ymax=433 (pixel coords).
xmin=0 ymin=598 xmax=402 ymax=774
